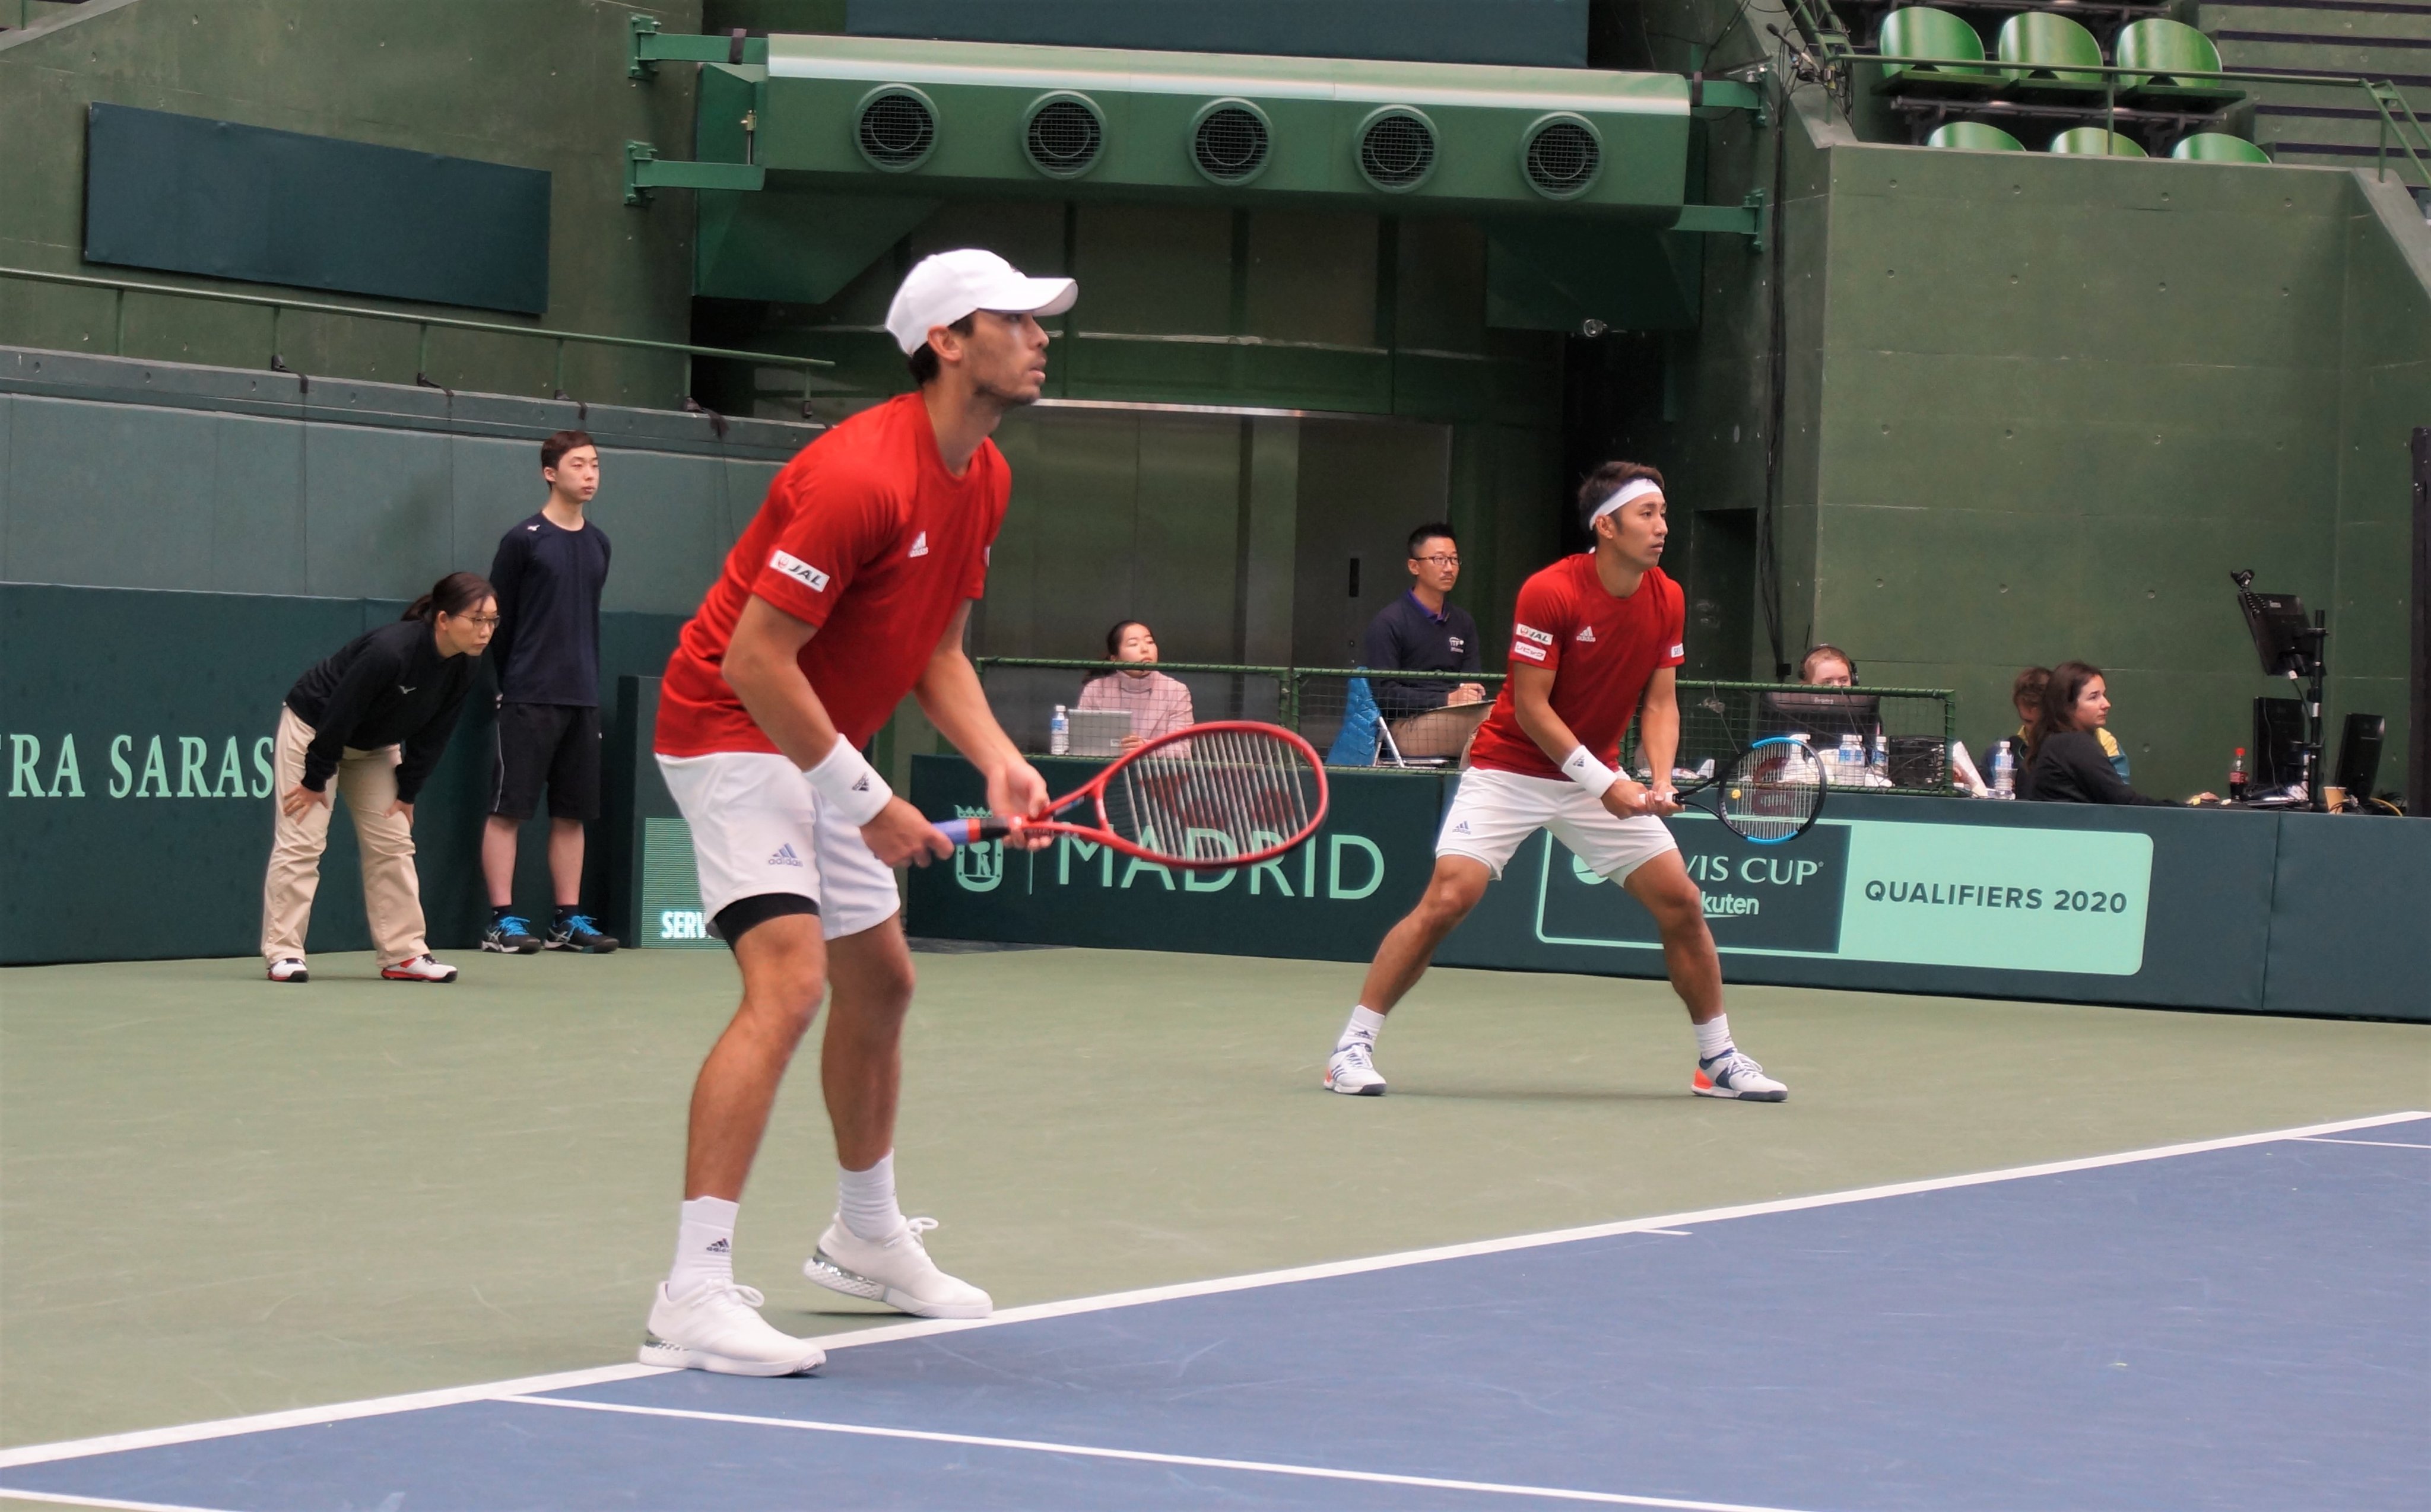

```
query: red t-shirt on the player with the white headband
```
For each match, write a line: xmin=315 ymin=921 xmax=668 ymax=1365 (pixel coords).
xmin=1468 ymin=552 xmax=1687 ymax=778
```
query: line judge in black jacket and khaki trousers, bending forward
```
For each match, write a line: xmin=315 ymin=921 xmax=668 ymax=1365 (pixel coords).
xmin=262 ymin=571 xmax=499 ymax=982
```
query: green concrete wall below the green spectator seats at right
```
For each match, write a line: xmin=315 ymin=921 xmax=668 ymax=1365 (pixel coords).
xmin=1789 ymin=146 xmax=2431 ymax=795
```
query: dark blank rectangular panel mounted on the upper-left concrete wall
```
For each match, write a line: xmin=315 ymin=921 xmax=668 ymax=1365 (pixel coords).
xmin=85 ymin=104 xmax=550 ymax=313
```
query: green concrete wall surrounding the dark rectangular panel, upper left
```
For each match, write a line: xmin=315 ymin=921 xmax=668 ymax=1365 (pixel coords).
xmin=0 ymin=0 xmax=700 ymax=408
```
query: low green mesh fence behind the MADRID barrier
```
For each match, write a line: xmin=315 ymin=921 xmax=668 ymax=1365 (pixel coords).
xmin=978 ymin=656 xmax=1957 ymax=795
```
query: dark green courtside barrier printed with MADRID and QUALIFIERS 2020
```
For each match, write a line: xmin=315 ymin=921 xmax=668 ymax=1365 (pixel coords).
xmin=907 ymin=756 xmax=2278 ymax=1009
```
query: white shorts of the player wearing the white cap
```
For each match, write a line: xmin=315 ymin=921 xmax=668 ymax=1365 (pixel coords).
xmin=659 ymin=751 xmax=902 ymax=941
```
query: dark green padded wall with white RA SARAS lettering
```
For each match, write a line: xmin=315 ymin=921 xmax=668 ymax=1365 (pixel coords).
xmin=0 ymin=583 xmax=683 ymax=963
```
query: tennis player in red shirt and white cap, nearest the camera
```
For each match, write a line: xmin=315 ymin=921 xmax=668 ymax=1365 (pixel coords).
xmin=642 ymin=250 xmax=1080 ymax=1376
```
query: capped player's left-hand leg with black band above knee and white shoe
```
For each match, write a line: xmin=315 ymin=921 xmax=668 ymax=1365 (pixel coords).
xmin=642 ymin=914 xmax=827 ymax=1376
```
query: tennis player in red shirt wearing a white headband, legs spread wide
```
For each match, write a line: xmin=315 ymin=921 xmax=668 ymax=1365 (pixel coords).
xmin=1325 ymin=462 xmax=1789 ymax=1104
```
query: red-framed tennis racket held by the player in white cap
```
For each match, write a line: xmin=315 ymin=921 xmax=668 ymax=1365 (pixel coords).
xmin=938 ymin=720 xmax=1327 ymax=871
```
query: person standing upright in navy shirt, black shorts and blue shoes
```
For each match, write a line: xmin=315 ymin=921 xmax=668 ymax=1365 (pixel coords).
xmin=481 ymin=430 xmax=615 ymax=955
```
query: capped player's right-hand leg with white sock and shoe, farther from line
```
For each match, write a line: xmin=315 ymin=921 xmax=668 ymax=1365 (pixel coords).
xmin=802 ymin=914 xmax=994 ymax=1317
